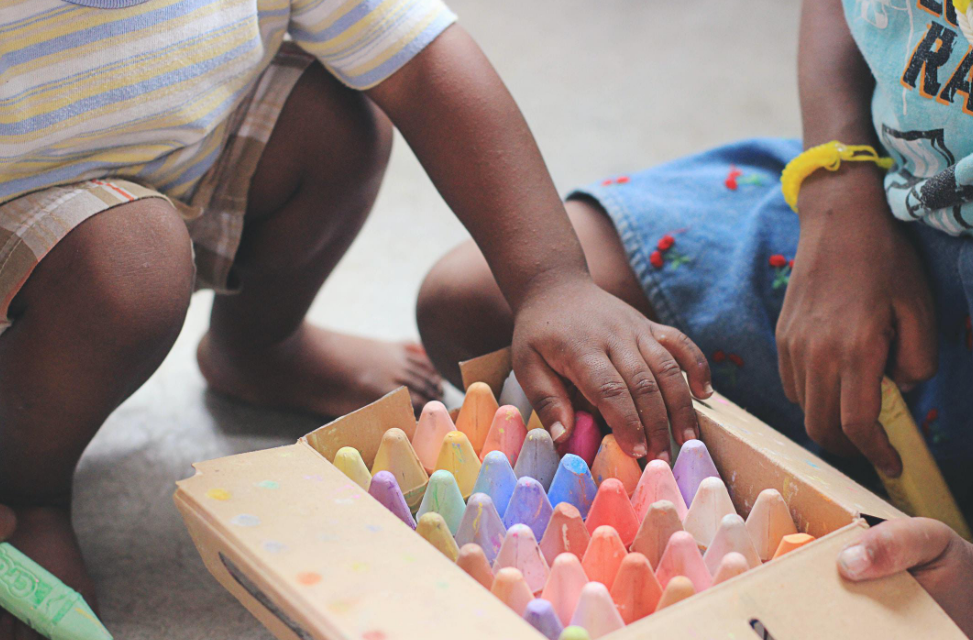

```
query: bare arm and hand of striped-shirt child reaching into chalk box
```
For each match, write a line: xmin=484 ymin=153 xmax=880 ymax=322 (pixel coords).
xmin=369 ymin=26 xmax=711 ymax=455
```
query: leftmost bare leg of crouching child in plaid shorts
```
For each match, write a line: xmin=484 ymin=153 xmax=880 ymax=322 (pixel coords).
xmin=0 ymin=199 xmax=193 ymax=640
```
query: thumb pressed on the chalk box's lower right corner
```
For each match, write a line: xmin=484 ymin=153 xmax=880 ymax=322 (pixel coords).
xmin=838 ymin=518 xmax=962 ymax=582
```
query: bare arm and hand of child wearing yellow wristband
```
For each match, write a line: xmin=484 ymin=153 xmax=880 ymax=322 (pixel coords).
xmin=777 ymin=0 xmax=936 ymax=477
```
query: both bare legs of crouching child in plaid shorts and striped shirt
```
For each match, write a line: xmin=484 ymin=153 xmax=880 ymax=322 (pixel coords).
xmin=0 ymin=65 xmax=440 ymax=640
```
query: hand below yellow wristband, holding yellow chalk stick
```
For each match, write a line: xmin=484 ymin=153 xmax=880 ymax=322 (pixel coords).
xmin=777 ymin=167 xmax=937 ymax=477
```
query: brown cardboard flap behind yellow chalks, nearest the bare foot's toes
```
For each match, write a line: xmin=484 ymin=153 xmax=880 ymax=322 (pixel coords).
xmin=302 ymin=387 xmax=416 ymax=468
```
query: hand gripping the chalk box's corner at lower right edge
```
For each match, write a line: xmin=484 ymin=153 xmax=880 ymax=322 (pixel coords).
xmin=838 ymin=518 xmax=973 ymax=637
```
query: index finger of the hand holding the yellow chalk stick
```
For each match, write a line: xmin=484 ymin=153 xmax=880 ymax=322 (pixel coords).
xmin=841 ymin=363 xmax=902 ymax=478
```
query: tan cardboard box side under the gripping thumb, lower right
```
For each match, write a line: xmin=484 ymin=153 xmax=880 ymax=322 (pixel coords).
xmin=609 ymin=521 xmax=966 ymax=640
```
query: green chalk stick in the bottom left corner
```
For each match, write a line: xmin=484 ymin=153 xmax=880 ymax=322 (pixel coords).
xmin=0 ymin=542 xmax=112 ymax=640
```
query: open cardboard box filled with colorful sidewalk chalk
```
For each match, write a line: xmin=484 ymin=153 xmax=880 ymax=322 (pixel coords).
xmin=175 ymin=350 xmax=964 ymax=640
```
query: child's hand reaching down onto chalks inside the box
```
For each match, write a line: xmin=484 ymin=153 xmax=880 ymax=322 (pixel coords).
xmin=513 ymin=279 xmax=713 ymax=461
